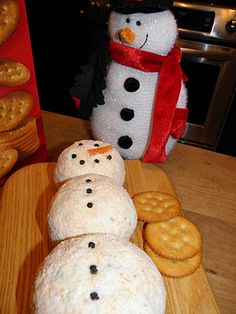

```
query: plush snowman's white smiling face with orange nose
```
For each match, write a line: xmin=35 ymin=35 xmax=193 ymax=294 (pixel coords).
xmin=109 ymin=10 xmax=177 ymax=55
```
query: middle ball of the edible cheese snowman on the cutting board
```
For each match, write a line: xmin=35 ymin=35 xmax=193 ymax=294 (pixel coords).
xmin=48 ymin=174 xmax=137 ymax=240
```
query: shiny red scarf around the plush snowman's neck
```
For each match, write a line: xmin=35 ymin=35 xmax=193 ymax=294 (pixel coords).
xmin=109 ymin=41 xmax=188 ymax=162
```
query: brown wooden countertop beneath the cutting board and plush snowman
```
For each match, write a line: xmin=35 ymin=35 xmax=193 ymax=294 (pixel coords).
xmin=42 ymin=111 xmax=236 ymax=314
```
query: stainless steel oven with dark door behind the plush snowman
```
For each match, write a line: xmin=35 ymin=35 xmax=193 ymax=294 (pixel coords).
xmin=173 ymin=0 xmax=236 ymax=150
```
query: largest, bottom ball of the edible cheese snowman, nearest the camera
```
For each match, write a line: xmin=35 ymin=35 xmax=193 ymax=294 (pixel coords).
xmin=33 ymin=234 xmax=166 ymax=314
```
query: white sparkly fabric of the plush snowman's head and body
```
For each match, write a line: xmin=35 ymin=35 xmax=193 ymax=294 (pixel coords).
xmin=91 ymin=10 xmax=187 ymax=159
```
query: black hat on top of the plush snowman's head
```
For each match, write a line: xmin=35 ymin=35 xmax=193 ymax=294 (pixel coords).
xmin=110 ymin=0 xmax=173 ymax=14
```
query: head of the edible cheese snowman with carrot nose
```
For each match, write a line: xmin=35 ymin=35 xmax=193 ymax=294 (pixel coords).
xmin=54 ymin=140 xmax=125 ymax=185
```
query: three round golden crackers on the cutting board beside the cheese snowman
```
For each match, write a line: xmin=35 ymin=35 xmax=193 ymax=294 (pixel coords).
xmin=133 ymin=191 xmax=202 ymax=278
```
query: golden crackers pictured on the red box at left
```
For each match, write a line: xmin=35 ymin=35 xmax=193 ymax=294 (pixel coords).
xmin=0 ymin=0 xmax=40 ymax=178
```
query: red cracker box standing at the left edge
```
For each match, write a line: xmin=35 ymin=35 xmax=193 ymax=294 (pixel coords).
xmin=0 ymin=0 xmax=47 ymax=185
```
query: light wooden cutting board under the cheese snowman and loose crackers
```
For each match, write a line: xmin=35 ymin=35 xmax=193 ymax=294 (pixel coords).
xmin=0 ymin=161 xmax=219 ymax=314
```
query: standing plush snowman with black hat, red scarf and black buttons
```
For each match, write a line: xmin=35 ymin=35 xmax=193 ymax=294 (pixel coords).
xmin=72 ymin=0 xmax=188 ymax=162
